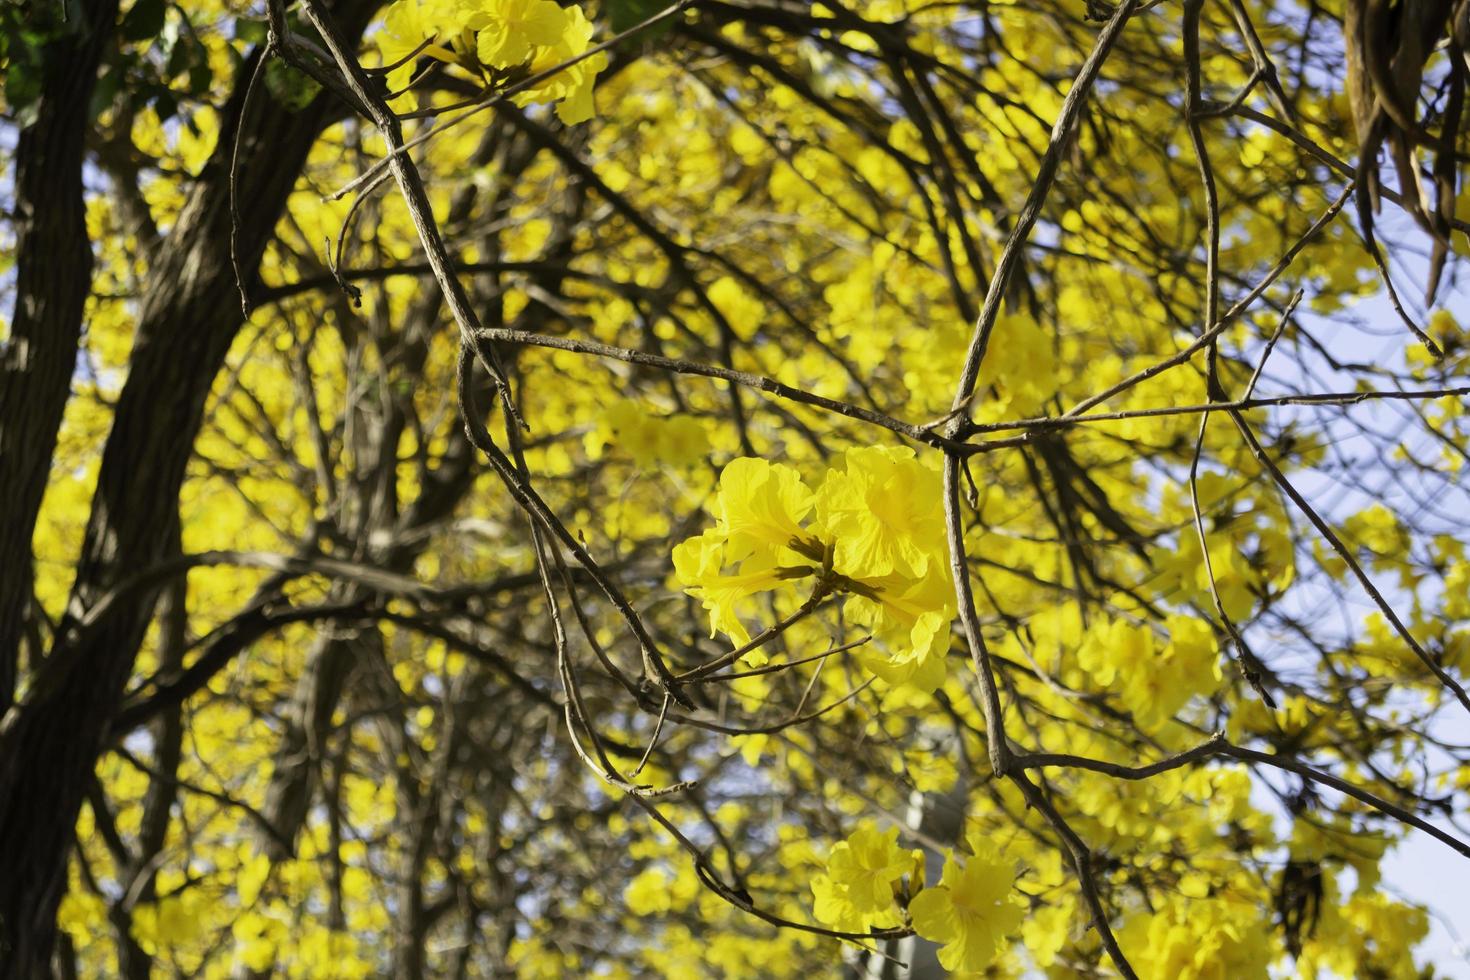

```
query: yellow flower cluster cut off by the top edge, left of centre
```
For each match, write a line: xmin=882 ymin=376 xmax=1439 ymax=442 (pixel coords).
xmin=378 ymin=0 xmax=607 ymax=125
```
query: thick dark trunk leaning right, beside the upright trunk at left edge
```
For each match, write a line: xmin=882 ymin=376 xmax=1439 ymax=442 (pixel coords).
xmin=0 ymin=0 xmax=376 ymax=977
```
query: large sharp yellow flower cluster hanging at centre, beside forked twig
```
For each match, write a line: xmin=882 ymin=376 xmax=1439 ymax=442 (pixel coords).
xmin=673 ymin=447 xmax=956 ymax=691
